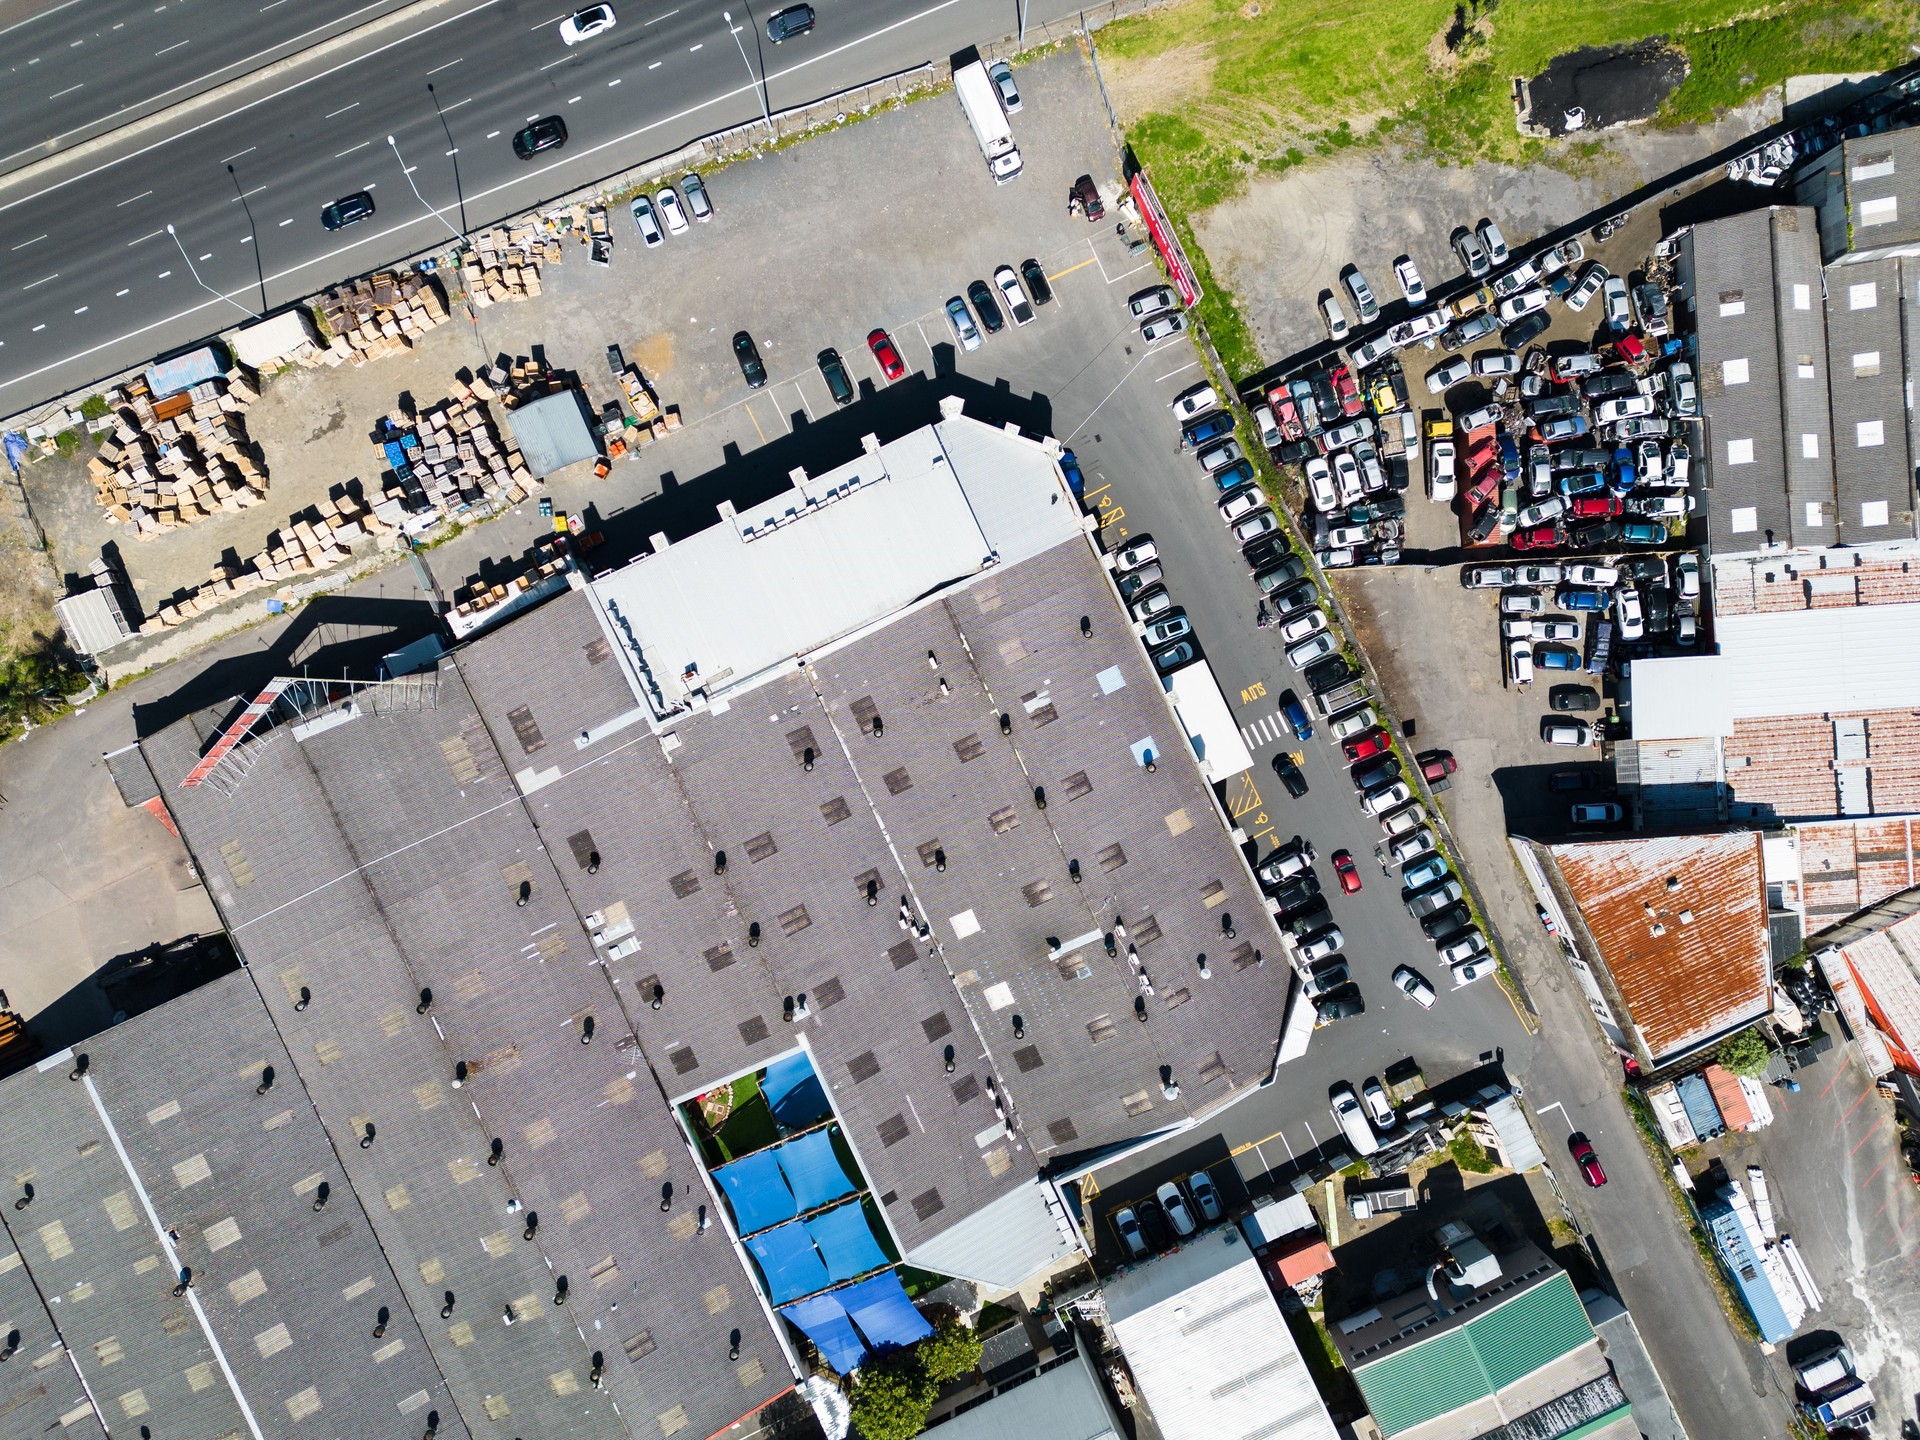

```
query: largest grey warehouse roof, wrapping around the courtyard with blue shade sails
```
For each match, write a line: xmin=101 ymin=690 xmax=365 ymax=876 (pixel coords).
xmin=116 ymin=422 xmax=1290 ymax=1436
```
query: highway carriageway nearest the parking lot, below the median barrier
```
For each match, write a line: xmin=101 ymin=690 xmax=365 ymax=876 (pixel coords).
xmin=0 ymin=0 xmax=1073 ymax=415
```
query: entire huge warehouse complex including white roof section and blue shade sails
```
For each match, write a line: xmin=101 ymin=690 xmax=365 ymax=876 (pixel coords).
xmin=0 ymin=401 xmax=1292 ymax=1436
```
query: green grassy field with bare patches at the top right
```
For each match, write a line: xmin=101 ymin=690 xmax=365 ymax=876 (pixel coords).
xmin=1098 ymin=0 xmax=1920 ymax=374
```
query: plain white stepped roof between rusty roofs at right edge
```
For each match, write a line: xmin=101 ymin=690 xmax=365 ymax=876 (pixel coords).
xmin=1634 ymin=605 xmax=1920 ymax=741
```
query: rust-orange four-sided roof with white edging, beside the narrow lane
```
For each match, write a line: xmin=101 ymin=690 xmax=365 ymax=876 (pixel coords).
xmin=1548 ymin=831 xmax=1772 ymax=1060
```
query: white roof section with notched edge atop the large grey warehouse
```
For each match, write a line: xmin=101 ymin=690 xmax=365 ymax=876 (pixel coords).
xmin=591 ymin=411 xmax=1081 ymax=720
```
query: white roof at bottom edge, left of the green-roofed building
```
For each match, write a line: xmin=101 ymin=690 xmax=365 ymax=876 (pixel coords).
xmin=1106 ymin=1229 xmax=1334 ymax=1440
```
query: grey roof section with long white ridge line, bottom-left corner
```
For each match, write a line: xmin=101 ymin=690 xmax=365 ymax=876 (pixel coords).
xmin=0 ymin=973 xmax=467 ymax=1436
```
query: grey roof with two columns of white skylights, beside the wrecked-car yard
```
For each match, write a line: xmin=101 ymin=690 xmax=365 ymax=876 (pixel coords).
xmin=1682 ymin=205 xmax=1836 ymax=555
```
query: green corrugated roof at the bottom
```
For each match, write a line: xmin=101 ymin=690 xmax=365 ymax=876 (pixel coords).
xmin=1354 ymin=1275 xmax=1594 ymax=1434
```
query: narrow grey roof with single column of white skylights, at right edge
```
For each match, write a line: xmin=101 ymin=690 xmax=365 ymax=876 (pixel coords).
xmin=1826 ymin=259 xmax=1920 ymax=545
